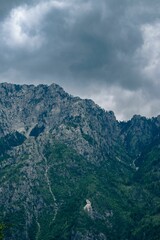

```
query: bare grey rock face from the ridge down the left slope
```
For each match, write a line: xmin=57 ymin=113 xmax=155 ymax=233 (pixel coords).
xmin=0 ymin=83 xmax=118 ymax=240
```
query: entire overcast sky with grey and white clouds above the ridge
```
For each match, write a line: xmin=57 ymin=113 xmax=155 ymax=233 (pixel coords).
xmin=0 ymin=0 xmax=160 ymax=119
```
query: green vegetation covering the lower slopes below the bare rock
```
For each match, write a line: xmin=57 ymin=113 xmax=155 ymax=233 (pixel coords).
xmin=0 ymin=138 xmax=160 ymax=240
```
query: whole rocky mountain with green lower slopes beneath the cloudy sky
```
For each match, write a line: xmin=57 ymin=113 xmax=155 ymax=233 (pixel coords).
xmin=0 ymin=83 xmax=160 ymax=240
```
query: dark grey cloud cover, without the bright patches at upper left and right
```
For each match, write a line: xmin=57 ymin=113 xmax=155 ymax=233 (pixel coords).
xmin=0 ymin=0 xmax=160 ymax=118
